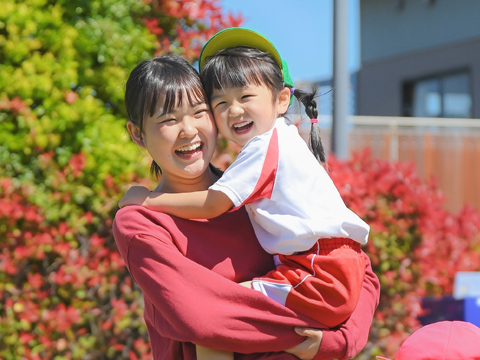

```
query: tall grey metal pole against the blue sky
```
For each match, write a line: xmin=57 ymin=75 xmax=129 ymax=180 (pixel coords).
xmin=332 ymin=0 xmax=350 ymax=160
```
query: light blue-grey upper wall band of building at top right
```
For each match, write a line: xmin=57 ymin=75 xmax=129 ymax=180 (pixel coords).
xmin=360 ymin=0 xmax=480 ymax=64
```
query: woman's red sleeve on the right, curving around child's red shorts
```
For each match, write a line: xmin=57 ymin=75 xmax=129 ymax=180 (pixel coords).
xmin=315 ymin=253 xmax=380 ymax=360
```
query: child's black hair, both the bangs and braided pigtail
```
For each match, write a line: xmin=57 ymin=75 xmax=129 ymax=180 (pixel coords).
xmin=200 ymin=46 xmax=326 ymax=162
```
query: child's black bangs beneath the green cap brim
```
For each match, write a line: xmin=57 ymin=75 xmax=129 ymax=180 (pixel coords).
xmin=201 ymin=47 xmax=282 ymax=99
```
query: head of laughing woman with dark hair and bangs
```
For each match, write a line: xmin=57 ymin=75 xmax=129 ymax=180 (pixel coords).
xmin=125 ymin=56 xmax=216 ymax=187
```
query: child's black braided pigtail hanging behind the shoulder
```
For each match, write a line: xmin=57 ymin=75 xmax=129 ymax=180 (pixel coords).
xmin=291 ymin=88 xmax=326 ymax=163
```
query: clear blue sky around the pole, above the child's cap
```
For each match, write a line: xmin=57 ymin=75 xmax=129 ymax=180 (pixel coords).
xmin=219 ymin=0 xmax=359 ymax=81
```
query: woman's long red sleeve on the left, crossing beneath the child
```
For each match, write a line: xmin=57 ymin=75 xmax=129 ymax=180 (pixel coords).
xmin=114 ymin=209 xmax=315 ymax=353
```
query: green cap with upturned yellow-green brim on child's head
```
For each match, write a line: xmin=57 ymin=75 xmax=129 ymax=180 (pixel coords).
xmin=199 ymin=27 xmax=294 ymax=87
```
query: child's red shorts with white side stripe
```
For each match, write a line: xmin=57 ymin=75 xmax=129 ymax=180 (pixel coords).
xmin=252 ymin=238 xmax=365 ymax=327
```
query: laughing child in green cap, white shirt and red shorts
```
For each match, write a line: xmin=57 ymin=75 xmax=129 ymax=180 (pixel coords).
xmin=120 ymin=28 xmax=369 ymax=358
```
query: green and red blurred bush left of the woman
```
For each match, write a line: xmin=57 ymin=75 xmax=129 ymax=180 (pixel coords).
xmin=0 ymin=0 xmax=241 ymax=360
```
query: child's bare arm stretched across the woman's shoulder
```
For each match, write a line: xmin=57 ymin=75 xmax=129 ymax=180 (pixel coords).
xmin=118 ymin=186 xmax=233 ymax=219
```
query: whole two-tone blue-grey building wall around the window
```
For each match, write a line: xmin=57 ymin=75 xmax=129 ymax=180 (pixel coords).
xmin=356 ymin=0 xmax=480 ymax=118
